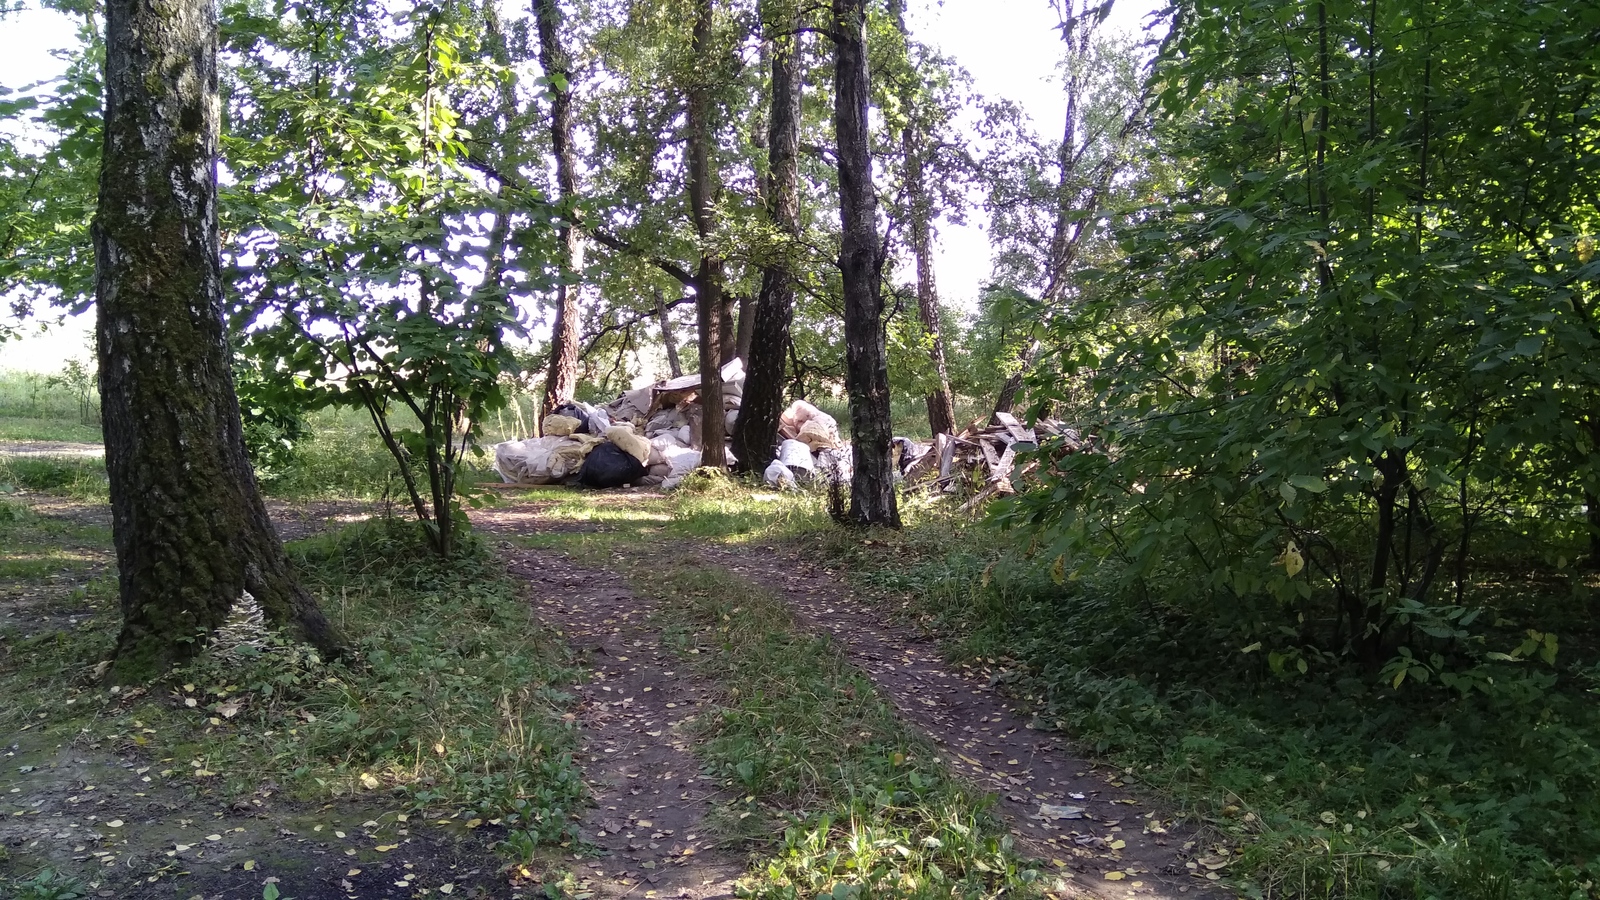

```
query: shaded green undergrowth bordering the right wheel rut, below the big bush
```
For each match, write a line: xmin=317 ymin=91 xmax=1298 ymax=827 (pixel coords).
xmin=806 ymin=517 xmax=1600 ymax=900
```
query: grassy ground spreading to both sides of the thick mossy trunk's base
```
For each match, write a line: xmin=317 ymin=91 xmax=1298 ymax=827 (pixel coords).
xmin=0 ymin=519 xmax=586 ymax=847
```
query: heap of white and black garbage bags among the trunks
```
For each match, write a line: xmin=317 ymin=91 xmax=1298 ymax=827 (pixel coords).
xmin=494 ymin=359 xmax=850 ymax=490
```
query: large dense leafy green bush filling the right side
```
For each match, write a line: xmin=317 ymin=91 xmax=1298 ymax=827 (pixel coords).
xmin=1000 ymin=0 xmax=1600 ymax=666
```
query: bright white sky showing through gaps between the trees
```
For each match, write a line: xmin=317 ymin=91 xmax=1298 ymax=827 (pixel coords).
xmin=0 ymin=0 xmax=1160 ymax=372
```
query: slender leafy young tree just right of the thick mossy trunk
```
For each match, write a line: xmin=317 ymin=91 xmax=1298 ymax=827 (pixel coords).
xmin=226 ymin=5 xmax=554 ymax=556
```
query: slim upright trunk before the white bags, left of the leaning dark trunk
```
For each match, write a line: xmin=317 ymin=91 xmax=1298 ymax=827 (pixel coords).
xmin=688 ymin=0 xmax=733 ymax=469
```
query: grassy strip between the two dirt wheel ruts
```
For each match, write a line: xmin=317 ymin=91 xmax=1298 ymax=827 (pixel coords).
xmin=632 ymin=565 xmax=1042 ymax=900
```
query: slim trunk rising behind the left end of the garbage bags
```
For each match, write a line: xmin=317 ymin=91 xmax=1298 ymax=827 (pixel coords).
xmin=533 ymin=0 xmax=584 ymax=418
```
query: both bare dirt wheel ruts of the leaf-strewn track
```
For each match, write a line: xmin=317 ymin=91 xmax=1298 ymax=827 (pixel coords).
xmin=477 ymin=493 xmax=1230 ymax=898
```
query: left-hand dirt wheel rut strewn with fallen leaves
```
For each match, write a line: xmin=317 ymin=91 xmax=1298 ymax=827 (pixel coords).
xmin=474 ymin=509 xmax=744 ymax=900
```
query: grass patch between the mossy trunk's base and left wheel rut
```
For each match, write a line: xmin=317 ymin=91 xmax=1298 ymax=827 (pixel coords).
xmin=156 ymin=519 xmax=584 ymax=842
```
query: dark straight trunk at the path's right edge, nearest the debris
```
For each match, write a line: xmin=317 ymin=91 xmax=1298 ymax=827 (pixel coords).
xmin=834 ymin=0 xmax=901 ymax=528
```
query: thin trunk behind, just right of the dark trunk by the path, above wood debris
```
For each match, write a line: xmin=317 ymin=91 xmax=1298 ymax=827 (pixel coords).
xmin=890 ymin=0 xmax=955 ymax=434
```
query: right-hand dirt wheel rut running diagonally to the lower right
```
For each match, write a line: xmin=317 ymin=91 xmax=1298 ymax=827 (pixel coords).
xmin=699 ymin=546 xmax=1234 ymax=900
